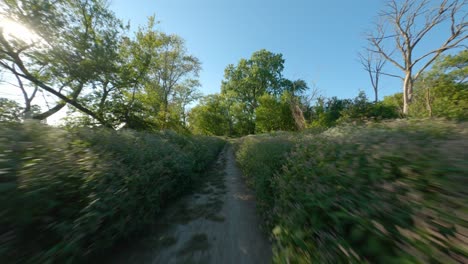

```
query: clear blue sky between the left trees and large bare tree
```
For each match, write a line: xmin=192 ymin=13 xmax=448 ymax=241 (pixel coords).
xmin=110 ymin=0 xmax=401 ymax=98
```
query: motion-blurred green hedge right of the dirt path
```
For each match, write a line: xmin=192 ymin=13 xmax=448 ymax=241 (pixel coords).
xmin=237 ymin=121 xmax=468 ymax=263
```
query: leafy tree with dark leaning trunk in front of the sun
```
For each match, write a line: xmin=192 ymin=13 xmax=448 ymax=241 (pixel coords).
xmin=0 ymin=0 xmax=125 ymax=126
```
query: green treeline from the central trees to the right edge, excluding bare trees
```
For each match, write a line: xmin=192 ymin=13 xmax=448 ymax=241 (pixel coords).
xmin=189 ymin=50 xmax=468 ymax=136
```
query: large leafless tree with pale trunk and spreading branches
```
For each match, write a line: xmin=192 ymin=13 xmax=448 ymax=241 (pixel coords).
xmin=368 ymin=0 xmax=468 ymax=115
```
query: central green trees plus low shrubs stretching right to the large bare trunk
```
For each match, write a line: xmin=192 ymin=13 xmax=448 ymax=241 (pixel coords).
xmin=188 ymin=50 xmax=399 ymax=136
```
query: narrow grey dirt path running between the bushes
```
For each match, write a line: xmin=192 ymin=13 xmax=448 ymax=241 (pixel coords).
xmin=102 ymin=146 xmax=271 ymax=264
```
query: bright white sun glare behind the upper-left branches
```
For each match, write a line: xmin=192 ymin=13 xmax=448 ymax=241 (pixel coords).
xmin=0 ymin=18 xmax=42 ymax=44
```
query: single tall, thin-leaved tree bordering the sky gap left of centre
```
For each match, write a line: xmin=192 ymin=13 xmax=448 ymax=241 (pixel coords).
xmin=119 ymin=17 xmax=201 ymax=129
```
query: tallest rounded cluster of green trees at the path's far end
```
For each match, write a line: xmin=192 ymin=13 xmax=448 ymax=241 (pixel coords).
xmin=189 ymin=49 xmax=314 ymax=136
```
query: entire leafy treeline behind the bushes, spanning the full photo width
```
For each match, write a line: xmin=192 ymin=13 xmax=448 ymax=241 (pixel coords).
xmin=0 ymin=0 xmax=468 ymax=136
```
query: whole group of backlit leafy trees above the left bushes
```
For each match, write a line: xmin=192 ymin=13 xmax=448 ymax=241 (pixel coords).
xmin=0 ymin=0 xmax=201 ymax=131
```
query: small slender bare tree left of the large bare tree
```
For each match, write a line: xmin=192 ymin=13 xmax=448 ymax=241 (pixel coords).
xmin=359 ymin=50 xmax=389 ymax=102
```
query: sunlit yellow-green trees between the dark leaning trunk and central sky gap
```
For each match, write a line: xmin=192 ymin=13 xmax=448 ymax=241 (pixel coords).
xmin=59 ymin=16 xmax=200 ymax=130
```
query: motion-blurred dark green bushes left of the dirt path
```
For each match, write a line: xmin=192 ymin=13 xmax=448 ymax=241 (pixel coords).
xmin=0 ymin=123 xmax=223 ymax=263
